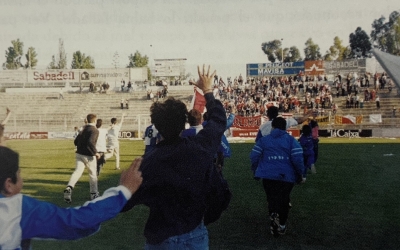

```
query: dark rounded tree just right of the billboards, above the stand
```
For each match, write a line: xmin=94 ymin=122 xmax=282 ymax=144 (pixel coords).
xmin=349 ymin=27 xmax=372 ymax=57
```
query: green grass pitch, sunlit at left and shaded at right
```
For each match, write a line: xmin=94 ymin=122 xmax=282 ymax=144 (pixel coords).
xmin=7 ymin=138 xmax=400 ymax=250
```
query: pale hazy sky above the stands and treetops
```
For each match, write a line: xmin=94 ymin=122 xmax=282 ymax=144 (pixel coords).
xmin=0 ymin=0 xmax=400 ymax=77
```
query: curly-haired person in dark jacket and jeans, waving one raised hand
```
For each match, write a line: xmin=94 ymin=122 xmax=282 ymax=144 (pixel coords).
xmin=120 ymin=64 xmax=230 ymax=250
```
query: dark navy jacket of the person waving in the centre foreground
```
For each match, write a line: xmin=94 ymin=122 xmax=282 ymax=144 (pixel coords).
xmin=123 ymin=93 xmax=226 ymax=244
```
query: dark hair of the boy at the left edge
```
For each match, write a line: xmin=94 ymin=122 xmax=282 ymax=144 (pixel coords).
xmin=0 ymin=146 xmax=19 ymax=191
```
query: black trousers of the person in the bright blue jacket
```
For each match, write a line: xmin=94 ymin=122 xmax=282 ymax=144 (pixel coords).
xmin=262 ymin=179 xmax=294 ymax=225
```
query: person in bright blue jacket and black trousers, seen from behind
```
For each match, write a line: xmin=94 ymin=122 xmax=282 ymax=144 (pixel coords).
xmin=250 ymin=117 xmax=305 ymax=235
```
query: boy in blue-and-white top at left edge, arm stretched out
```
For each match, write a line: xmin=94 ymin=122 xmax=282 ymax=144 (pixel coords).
xmin=0 ymin=146 xmax=142 ymax=249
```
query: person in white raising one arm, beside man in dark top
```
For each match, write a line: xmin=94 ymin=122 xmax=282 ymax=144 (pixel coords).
xmin=105 ymin=114 xmax=125 ymax=169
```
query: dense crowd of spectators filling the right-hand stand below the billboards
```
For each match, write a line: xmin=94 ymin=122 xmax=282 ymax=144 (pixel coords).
xmin=206 ymin=72 xmax=393 ymax=116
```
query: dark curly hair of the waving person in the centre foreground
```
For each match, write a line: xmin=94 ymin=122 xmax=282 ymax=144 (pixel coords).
xmin=150 ymin=97 xmax=188 ymax=140
